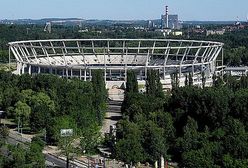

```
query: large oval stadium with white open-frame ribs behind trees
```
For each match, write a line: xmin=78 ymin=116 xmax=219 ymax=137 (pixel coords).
xmin=9 ymin=39 xmax=223 ymax=89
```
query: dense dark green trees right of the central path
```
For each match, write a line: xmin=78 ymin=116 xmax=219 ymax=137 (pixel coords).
xmin=113 ymin=70 xmax=248 ymax=168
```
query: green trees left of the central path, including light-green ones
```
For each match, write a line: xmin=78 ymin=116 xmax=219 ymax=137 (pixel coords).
xmin=0 ymin=70 xmax=107 ymax=153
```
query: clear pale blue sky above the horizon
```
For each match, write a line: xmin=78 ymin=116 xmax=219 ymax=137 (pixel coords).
xmin=0 ymin=0 xmax=248 ymax=21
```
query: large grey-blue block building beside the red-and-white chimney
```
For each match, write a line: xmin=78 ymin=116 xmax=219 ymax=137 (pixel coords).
xmin=161 ymin=15 xmax=182 ymax=29
